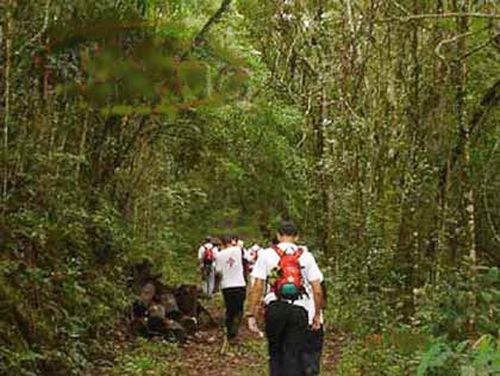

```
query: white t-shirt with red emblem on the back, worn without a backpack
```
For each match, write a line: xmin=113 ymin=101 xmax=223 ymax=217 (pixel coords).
xmin=215 ymin=246 xmax=246 ymax=289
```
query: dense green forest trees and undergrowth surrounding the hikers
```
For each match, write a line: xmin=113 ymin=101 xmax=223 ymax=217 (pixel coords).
xmin=0 ymin=0 xmax=500 ymax=375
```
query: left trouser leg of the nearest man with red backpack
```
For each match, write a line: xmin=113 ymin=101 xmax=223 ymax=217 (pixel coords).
xmin=265 ymin=302 xmax=288 ymax=376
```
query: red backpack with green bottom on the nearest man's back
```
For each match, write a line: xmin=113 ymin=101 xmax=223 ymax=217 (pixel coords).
xmin=272 ymin=246 xmax=304 ymax=300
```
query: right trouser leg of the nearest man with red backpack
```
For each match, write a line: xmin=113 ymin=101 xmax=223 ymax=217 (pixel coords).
xmin=283 ymin=304 xmax=308 ymax=376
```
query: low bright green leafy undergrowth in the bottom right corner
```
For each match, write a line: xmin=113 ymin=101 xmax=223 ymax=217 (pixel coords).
xmin=338 ymin=328 xmax=500 ymax=376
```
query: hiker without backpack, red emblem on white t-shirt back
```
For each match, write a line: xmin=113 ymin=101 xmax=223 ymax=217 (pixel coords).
xmin=215 ymin=236 xmax=246 ymax=342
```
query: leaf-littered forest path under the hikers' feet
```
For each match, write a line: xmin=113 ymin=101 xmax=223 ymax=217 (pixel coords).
xmin=87 ymin=299 xmax=340 ymax=376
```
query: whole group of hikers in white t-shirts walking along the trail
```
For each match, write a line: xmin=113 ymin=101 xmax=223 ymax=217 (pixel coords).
xmin=198 ymin=221 xmax=326 ymax=376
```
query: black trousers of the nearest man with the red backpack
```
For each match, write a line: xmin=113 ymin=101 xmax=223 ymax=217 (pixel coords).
xmin=266 ymin=301 xmax=308 ymax=376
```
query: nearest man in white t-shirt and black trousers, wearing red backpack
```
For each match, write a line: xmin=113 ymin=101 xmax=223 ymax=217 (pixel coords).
xmin=246 ymin=221 xmax=323 ymax=376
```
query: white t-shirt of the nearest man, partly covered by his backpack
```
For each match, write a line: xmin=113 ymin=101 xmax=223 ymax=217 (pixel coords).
xmin=252 ymin=243 xmax=323 ymax=324
